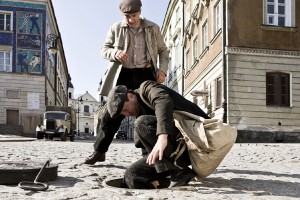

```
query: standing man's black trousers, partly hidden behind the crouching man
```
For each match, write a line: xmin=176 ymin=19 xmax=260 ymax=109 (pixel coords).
xmin=94 ymin=67 xmax=156 ymax=153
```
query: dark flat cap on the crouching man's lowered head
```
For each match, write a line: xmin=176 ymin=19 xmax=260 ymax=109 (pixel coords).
xmin=107 ymin=85 xmax=128 ymax=117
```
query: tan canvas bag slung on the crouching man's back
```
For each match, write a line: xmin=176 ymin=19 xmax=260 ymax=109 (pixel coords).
xmin=173 ymin=111 xmax=237 ymax=180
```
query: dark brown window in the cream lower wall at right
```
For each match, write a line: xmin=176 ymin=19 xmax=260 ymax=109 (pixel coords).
xmin=266 ymin=72 xmax=290 ymax=107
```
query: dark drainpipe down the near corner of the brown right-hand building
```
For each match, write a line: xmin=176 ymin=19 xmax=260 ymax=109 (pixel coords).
xmin=222 ymin=0 xmax=228 ymax=123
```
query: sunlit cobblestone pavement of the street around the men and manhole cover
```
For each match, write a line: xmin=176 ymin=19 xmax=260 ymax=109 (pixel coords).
xmin=0 ymin=139 xmax=300 ymax=200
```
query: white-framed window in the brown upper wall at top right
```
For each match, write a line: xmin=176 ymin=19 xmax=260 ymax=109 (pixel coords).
xmin=265 ymin=0 xmax=295 ymax=26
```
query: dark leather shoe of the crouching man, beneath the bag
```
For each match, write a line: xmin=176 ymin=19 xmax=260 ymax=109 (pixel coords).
xmin=169 ymin=167 xmax=196 ymax=188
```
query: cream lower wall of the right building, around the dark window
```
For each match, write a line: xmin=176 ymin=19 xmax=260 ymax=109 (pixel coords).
xmin=228 ymin=48 xmax=300 ymax=131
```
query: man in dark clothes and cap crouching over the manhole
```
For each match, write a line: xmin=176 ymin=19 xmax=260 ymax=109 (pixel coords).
xmin=107 ymin=81 xmax=209 ymax=189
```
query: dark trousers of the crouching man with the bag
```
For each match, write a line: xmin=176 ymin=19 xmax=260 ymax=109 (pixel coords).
xmin=124 ymin=115 xmax=190 ymax=189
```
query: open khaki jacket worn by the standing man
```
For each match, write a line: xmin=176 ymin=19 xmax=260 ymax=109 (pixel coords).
xmin=100 ymin=18 xmax=169 ymax=96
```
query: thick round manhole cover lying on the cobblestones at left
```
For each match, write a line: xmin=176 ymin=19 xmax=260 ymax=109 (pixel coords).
xmin=0 ymin=160 xmax=58 ymax=185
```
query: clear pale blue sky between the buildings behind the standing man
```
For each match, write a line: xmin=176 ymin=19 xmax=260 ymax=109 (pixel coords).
xmin=52 ymin=0 xmax=169 ymax=100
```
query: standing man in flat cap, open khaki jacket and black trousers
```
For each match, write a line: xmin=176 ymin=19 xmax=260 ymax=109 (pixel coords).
xmin=84 ymin=0 xmax=169 ymax=164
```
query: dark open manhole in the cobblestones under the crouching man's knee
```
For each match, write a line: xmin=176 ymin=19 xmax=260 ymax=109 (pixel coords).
xmin=105 ymin=178 xmax=170 ymax=189
